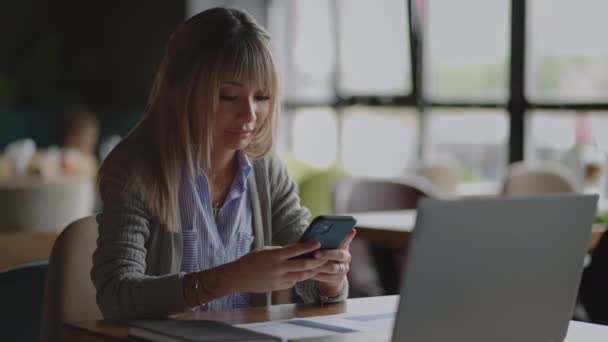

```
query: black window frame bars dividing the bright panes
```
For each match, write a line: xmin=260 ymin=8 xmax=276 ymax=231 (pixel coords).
xmin=271 ymin=0 xmax=608 ymax=172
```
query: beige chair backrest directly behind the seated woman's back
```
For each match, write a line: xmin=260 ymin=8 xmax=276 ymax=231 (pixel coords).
xmin=41 ymin=216 xmax=102 ymax=341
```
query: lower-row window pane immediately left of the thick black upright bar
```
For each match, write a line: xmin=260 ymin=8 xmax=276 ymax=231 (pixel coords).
xmin=425 ymin=109 xmax=509 ymax=182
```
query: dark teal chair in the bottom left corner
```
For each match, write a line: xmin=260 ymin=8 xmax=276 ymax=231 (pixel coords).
xmin=0 ymin=261 xmax=48 ymax=341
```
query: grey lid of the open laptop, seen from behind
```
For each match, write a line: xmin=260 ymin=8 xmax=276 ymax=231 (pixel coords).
xmin=393 ymin=194 xmax=598 ymax=342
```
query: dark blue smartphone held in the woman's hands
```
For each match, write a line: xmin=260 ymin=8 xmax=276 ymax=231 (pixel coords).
xmin=297 ymin=215 xmax=357 ymax=258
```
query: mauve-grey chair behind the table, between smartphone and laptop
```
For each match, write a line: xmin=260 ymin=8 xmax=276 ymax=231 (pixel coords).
xmin=334 ymin=177 xmax=439 ymax=297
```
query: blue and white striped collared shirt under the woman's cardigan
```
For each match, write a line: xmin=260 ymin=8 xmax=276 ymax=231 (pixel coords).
xmin=179 ymin=151 xmax=253 ymax=311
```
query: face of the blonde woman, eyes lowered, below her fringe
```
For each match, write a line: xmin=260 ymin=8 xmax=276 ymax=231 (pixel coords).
xmin=213 ymin=80 xmax=272 ymax=150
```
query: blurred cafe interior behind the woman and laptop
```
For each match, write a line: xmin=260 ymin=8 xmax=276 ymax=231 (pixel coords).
xmin=0 ymin=0 xmax=608 ymax=341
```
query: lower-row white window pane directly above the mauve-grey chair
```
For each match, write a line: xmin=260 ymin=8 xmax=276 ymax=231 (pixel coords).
xmin=341 ymin=106 xmax=418 ymax=177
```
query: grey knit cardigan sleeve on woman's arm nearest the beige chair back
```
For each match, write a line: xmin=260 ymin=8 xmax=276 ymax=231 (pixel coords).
xmin=91 ymin=171 xmax=188 ymax=319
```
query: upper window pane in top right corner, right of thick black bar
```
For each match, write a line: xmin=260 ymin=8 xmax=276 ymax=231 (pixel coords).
xmin=526 ymin=0 xmax=608 ymax=103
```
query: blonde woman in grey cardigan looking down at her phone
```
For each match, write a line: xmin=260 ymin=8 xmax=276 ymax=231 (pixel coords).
xmin=91 ymin=8 xmax=355 ymax=319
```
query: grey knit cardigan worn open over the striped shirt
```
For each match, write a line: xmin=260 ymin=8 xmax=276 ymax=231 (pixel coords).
xmin=91 ymin=142 xmax=348 ymax=319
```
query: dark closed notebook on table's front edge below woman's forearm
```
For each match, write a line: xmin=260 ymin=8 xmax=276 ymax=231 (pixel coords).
xmin=129 ymin=319 xmax=281 ymax=342
